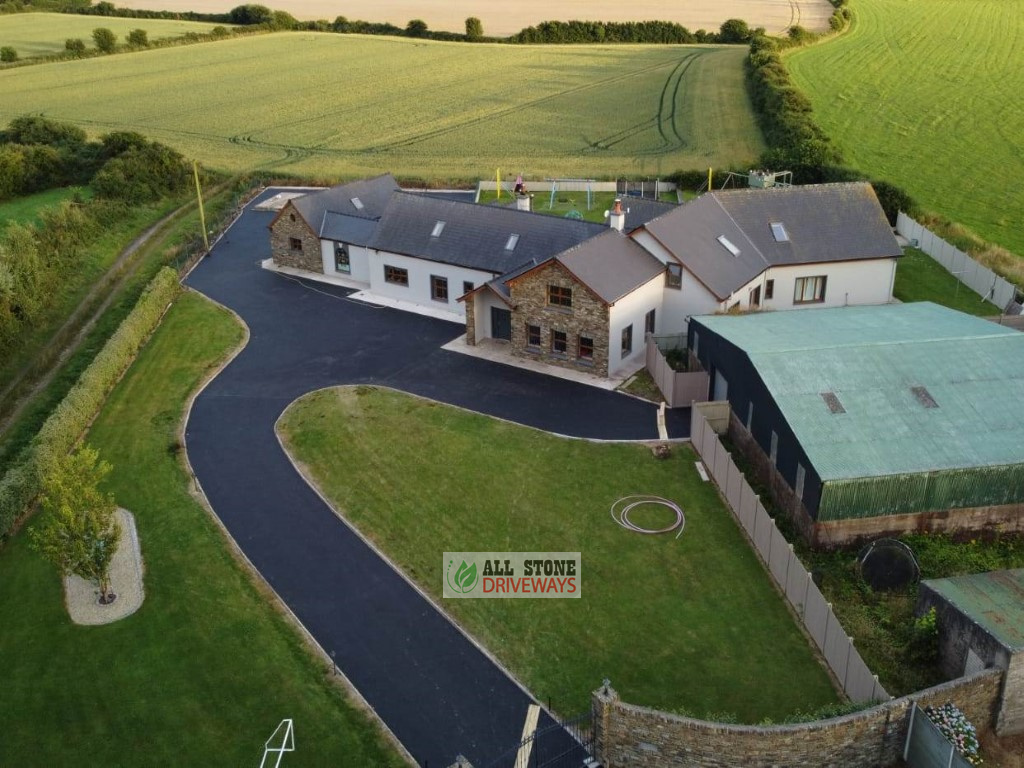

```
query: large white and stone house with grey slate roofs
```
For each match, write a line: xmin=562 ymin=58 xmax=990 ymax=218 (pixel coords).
xmin=270 ymin=175 xmax=901 ymax=376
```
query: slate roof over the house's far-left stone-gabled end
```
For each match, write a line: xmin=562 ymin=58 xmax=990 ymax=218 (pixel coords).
xmin=292 ymin=173 xmax=398 ymax=246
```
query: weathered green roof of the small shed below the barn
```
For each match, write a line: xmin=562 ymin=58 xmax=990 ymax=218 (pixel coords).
xmin=924 ymin=568 xmax=1024 ymax=650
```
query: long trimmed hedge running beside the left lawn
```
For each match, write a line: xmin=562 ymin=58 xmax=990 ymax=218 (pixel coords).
xmin=0 ymin=267 xmax=181 ymax=539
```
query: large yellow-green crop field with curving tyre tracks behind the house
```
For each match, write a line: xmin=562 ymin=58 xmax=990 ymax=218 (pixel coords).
xmin=0 ymin=33 xmax=764 ymax=179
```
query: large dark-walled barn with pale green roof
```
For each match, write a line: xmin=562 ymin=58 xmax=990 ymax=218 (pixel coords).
xmin=688 ymin=302 xmax=1024 ymax=544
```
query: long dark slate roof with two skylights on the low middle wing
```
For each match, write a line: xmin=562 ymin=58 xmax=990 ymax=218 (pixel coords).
xmin=369 ymin=191 xmax=607 ymax=274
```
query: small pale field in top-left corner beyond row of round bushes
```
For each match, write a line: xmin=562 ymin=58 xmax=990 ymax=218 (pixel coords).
xmin=0 ymin=13 xmax=216 ymax=58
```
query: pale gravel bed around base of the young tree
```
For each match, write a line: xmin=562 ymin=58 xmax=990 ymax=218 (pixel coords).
xmin=65 ymin=508 xmax=145 ymax=626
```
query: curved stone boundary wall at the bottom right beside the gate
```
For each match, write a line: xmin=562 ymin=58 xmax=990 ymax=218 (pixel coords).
xmin=592 ymin=670 xmax=1002 ymax=768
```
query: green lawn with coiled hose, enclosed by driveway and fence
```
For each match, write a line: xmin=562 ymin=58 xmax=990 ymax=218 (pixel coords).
xmin=282 ymin=387 xmax=837 ymax=722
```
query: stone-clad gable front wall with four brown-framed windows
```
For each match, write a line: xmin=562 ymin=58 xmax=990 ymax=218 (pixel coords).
xmin=509 ymin=263 xmax=608 ymax=376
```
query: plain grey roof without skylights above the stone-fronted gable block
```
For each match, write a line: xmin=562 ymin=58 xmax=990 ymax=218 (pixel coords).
xmin=555 ymin=228 xmax=665 ymax=304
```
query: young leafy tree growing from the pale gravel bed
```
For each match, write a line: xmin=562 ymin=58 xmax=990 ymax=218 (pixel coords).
xmin=30 ymin=445 xmax=121 ymax=604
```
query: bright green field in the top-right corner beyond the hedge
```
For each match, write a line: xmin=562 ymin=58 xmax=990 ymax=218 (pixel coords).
xmin=788 ymin=0 xmax=1024 ymax=256
